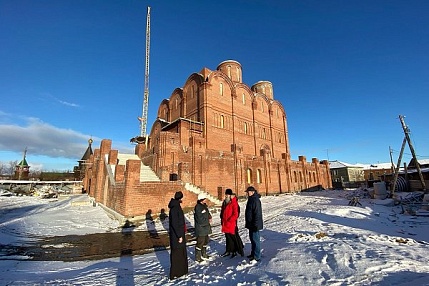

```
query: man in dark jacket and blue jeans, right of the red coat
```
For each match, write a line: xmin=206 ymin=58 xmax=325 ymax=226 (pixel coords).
xmin=245 ymin=186 xmax=264 ymax=261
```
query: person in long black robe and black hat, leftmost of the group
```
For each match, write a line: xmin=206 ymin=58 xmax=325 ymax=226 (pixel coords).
xmin=168 ymin=191 xmax=188 ymax=280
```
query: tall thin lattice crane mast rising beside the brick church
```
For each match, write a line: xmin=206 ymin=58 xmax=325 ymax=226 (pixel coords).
xmin=130 ymin=7 xmax=150 ymax=144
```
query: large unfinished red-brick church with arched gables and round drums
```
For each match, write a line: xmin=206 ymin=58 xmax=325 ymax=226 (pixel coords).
xmin=84 ymin=60 xmax=332 ymax=221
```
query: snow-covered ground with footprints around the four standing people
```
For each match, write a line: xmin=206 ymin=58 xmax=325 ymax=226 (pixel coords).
xmin=0 ymin=191 xmax=429 ymax=286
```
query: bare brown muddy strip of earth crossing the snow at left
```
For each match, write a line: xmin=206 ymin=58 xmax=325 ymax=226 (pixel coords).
xmin=0 ymin=231 xmax=194 ymax=261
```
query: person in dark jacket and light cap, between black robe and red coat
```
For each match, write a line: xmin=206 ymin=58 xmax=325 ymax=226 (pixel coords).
xmin=194 ymin=193 xmax=212 ymax=262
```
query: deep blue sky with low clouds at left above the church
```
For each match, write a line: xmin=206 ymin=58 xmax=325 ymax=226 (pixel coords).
xmin=0 ymin=0 xmax=429 ymax=170
